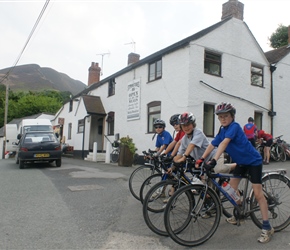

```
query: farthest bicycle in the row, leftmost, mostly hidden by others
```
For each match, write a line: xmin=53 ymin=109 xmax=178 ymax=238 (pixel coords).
xmin=129 ymin=149 xmax=162 ymax=200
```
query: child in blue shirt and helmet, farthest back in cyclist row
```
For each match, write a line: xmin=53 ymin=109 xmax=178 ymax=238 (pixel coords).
xmin=153 ymin=119 xmax=173 ymax=155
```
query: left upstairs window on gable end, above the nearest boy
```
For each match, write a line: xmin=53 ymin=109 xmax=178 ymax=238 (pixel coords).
xmin=204 ymin=51 xmax=222 ymax=76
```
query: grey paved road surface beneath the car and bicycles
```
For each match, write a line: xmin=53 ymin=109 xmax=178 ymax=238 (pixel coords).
xmin=0 ymin=158 xmax=290 ymax=250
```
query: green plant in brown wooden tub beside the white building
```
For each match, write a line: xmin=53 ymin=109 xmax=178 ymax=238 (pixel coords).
xmin=118 ymin=135 xmax=137 ymax=167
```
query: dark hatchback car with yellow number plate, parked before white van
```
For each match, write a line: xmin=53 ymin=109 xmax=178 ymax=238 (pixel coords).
xmin=15 ymin=131 xmax=62 ymax=169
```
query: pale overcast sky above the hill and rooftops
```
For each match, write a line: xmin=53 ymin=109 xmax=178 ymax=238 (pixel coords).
xmin=0 ymin=0 xmax=290 ymax=84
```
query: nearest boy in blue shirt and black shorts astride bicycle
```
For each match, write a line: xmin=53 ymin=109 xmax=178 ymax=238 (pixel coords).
xmin=197 ymin=102 xmax=274 ymax=243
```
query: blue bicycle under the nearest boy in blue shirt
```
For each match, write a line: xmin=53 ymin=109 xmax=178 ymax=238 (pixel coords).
xmin=164 ymin=162 xmax=290 ymax=247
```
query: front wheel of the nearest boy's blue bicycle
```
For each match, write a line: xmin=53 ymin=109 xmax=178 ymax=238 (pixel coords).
xmin=164 ymin=184 xmax=221 ymax=247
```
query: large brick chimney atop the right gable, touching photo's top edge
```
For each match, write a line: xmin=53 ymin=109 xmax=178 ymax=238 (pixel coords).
xmin=222 ymin=0 xmax=244 ymax=21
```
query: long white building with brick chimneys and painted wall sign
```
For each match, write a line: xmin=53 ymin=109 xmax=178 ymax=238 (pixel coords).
xmin=54 ymin=0 xmax=290 ymax=158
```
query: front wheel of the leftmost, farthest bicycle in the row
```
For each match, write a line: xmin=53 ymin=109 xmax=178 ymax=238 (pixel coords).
xmin=129 ymin=165 xmax=160 ymax=200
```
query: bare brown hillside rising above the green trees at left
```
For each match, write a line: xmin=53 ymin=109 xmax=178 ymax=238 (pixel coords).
xmin=0 ymin=64 xmax=87 ymax=95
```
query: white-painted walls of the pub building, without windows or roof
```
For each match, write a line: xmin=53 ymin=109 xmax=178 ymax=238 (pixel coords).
xmin=54 ymin=19 xmax=290 ymax=154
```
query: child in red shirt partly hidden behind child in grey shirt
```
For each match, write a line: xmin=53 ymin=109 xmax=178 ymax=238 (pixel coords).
xmin=162 ymin=114 xmax=184 ymax=158
